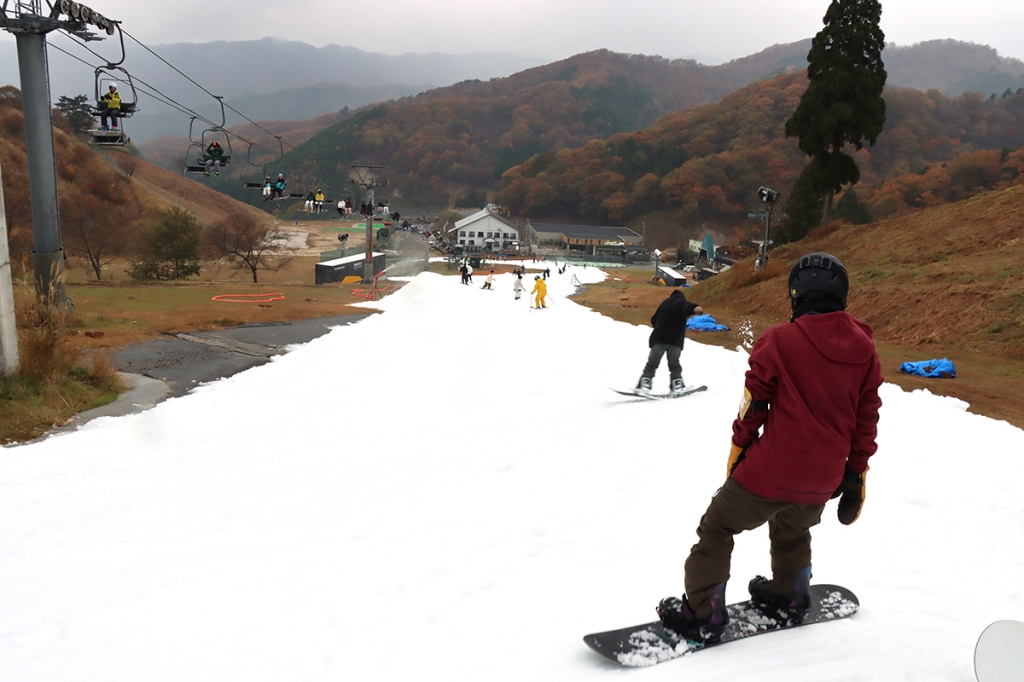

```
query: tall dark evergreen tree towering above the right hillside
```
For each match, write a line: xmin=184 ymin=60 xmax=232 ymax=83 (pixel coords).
xmin=785 ymin=0 xmax=886 ymax=224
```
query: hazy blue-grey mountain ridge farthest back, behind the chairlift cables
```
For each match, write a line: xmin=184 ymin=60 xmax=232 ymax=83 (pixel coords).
xmin=0 ymin=35 xmax=542 ymax=142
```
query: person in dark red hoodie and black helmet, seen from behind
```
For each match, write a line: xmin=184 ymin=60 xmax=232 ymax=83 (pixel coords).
xmin=657 ymin=253 xmax=883 ymax=642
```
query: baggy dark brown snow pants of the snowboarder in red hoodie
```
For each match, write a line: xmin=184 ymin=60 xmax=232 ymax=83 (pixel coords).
xmin=685 ymin=477 xmax=824 ymax=616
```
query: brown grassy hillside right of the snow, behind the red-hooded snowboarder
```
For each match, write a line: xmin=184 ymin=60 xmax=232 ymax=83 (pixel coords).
xmin=583 ymin=180 xmax=1024 ymax=428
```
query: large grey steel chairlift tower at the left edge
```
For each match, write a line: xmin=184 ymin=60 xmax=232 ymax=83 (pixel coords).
xmin=0 ymin=0 xmax=118 ymax=312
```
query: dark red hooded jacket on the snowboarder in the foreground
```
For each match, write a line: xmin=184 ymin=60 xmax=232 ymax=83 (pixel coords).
xmin=732 ymin=311 xmax=883 ymax=505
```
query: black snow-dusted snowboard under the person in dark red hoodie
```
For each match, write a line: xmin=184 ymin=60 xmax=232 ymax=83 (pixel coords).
xmin=583 ymin=585 xmax=856 ymax=667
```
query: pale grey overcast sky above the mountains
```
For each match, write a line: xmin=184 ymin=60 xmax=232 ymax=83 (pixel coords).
xmin=3 ymin=0 xmax=1024 ymax=62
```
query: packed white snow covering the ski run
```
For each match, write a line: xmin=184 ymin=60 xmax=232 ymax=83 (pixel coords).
xmin=0 ymin=267 xmax=1024 ymax=682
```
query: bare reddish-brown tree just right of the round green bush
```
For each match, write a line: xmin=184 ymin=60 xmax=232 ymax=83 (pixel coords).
xmin=206 ymin=206 xmax=292 ymax=284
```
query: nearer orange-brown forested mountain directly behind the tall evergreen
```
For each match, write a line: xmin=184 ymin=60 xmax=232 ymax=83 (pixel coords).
xmin=498 ymin=72 xmax=1024 ymax=246
